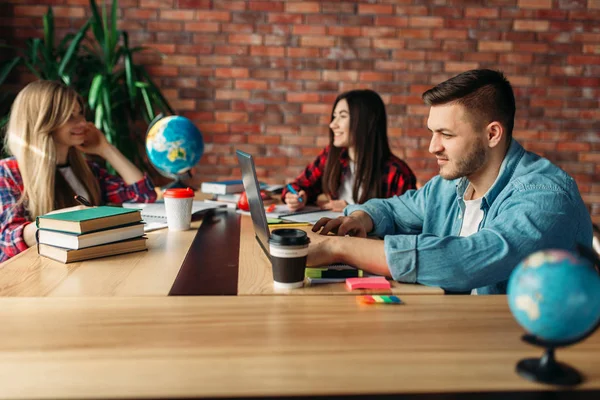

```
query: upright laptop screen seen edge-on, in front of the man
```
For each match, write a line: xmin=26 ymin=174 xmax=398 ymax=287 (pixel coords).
xmin=236 ymin=150 xmax=270 ymax=258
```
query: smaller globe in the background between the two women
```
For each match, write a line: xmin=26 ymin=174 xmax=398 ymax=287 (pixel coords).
xmin=146 ymin=114 xmax=204 ymax=188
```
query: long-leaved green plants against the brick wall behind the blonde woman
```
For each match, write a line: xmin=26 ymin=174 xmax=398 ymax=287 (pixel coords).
xmin=0 ymin=0 xmax=174 ymax=169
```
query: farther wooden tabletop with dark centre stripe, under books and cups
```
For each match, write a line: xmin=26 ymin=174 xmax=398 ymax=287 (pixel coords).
xmin=0 ymin=209 xmax=443 ymax=297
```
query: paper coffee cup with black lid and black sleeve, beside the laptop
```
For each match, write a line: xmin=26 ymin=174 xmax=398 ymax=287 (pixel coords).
xmin=269 ymin=229 xmax=310 ymax=289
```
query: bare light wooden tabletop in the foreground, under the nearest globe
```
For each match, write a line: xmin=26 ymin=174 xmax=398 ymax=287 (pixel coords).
xmin=0 ymin=296 xmax=600 ymax=399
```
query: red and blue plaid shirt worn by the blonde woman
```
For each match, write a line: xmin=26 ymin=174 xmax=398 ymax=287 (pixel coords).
xmin=0 ymin=157 xmax=156 ymax=262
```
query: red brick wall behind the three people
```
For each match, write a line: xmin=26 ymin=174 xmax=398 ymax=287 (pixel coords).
xmin=0 ymin=0 xmax=600 ymax=222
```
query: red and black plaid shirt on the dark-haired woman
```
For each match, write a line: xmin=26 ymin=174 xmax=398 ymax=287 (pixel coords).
xmin=281 ymin=146 xmax=417 ymax=203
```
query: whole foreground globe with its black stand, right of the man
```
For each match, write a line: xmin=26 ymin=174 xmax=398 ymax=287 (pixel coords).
xmin=507 ymin=248 xmax=600 ymax=385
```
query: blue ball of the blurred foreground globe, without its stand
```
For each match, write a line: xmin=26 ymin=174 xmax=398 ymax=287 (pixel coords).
xmin=507 ymin=250 xmax=600 ymax=342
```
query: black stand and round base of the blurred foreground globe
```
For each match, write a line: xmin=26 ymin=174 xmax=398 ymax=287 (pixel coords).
xmin=517 ymin=335 xmax=583 ymax=386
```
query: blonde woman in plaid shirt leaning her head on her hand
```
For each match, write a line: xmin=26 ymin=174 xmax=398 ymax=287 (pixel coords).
xmin=0 ymin=81 xmax=156 ymax=262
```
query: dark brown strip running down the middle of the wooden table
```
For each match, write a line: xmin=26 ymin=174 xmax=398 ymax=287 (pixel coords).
xmin=169 ymin=209 xmax=240 ymax=296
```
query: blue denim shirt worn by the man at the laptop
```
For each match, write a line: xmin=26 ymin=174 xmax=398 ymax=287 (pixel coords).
xmin=344 ymin=139 xmax=592 ymax=294
